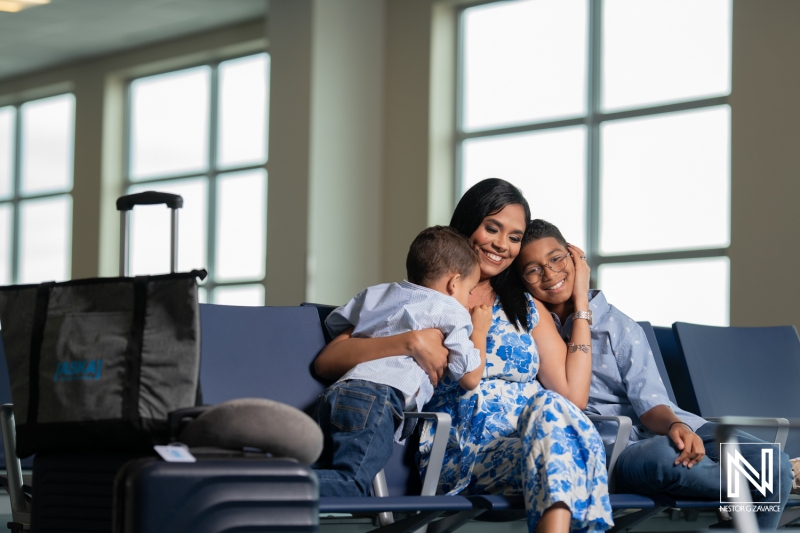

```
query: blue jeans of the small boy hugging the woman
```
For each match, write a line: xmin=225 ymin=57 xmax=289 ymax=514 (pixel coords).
xmin=313 ymin=380 xmax=404 ymax=496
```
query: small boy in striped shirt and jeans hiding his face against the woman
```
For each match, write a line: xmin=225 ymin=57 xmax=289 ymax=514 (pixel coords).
xmin=314 ymin=226 xmax=492 ymax=496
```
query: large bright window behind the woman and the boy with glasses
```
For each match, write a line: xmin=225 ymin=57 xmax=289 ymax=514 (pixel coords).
xmin=456 ymin=0 xmax=731 ymax=325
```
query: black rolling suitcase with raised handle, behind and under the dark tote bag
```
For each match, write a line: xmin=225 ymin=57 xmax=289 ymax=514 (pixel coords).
xmin=23 ymin=192 xmax=194 ymax=533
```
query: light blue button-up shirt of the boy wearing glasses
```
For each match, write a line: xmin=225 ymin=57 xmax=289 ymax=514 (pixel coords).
xmin=551 ymin=290 xmax=706 ymax=445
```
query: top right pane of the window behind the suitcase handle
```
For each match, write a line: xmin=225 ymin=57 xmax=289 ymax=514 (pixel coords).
xmin=217 ymin=54 xmax=269 ymax=168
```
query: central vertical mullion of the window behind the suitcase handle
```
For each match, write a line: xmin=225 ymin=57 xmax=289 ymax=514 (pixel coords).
xmin=206 ymin=63 xmax=219 ymax=302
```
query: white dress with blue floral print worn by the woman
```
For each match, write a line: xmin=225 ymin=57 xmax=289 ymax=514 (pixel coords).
xmin=419 ymin=296 xmax=614 ymax=532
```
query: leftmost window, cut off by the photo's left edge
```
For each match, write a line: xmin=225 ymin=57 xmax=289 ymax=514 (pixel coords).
xmin=0 ymin=94 xmax=75 ymax=285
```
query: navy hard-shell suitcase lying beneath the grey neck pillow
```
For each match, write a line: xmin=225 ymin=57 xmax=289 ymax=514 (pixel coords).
xmin=114 ymin=458 xmax=319 ymax=533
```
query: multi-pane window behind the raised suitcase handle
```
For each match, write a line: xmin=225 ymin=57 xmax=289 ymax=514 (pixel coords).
xmin=126 ymin=54 xmax=269 ymax=305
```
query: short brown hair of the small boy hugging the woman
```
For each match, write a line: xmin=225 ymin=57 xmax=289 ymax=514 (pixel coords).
xmin=406 ymin=226 xmax=478 ymax=285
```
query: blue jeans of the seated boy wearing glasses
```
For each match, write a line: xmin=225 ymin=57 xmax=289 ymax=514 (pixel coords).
xmin=614 ymin=422 xmax=794 ymax=530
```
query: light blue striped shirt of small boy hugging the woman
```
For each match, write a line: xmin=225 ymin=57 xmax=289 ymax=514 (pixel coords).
xmin=325 ymin=281 xmax=481 ymax=410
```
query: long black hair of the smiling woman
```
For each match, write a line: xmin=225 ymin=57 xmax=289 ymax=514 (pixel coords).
xmin=450 ymin=178 xmax=531 ymax=330
